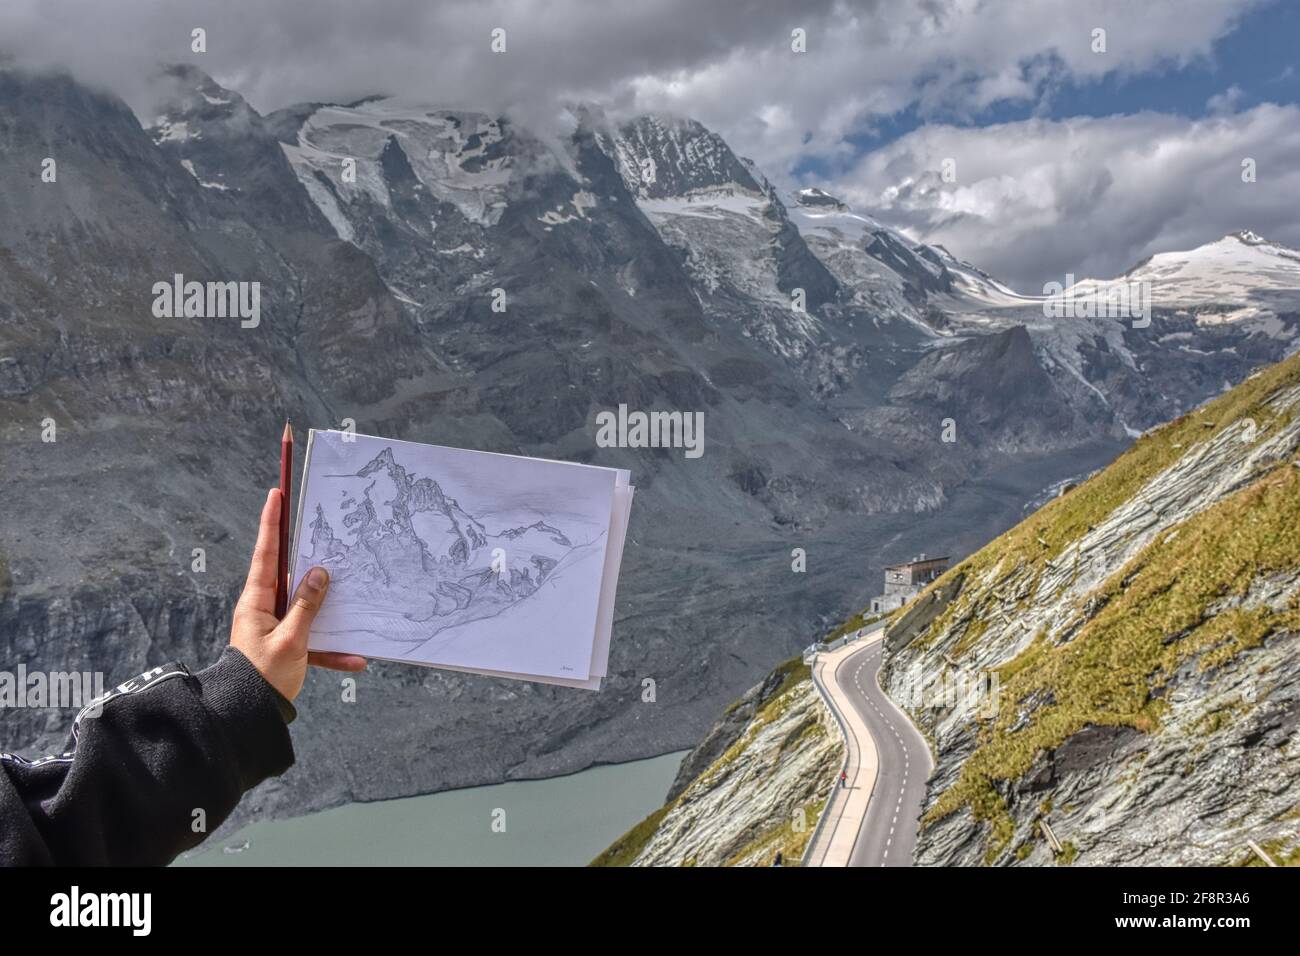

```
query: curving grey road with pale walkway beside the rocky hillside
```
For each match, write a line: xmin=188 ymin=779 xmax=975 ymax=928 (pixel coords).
xmin=807 ymin=628 xmax=933 ymax=866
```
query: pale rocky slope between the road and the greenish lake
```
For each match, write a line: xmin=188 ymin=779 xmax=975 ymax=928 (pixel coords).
xmin=597 ymin=661 xmax=844 ymax=866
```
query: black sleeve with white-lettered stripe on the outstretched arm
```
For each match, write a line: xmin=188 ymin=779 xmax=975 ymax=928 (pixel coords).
xmin=0 ymin=646 xmax=294 ymax=866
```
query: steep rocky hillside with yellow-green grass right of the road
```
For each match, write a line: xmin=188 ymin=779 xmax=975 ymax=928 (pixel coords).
xmin=884 ymin=356 xmax=1300 ymax=866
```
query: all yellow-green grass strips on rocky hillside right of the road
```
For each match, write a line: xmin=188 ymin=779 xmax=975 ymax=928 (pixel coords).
xmin=894 ymin=355 xmax=1300 ymax=858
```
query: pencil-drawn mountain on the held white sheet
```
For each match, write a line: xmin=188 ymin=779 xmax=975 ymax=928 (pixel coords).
xmin=303 ymin=447 xmax=592 ymax=657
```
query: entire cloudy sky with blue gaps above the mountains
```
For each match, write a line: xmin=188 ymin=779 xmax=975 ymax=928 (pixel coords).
xmin=0 ymin=0 xmax=1300 ymax=291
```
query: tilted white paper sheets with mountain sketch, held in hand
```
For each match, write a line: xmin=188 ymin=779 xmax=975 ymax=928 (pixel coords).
xmin=290 ymin=429 xmax=634 ymax=691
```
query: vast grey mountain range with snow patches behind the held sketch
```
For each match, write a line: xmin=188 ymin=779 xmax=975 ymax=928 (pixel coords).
xmin=0 ymin=68 xmax=1300 ymax=832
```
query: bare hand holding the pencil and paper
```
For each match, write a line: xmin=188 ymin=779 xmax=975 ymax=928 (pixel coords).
xmin=230 ymin=488 xmax=365 ymax=700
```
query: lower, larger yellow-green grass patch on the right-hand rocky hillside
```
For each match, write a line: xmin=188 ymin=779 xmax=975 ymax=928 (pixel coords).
xmin=946 ymin=467 xmax=1300 ymax=856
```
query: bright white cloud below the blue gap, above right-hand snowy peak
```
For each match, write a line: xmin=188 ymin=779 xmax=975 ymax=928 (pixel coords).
xmin=826 ymin=104 xmax=1300 ymax=291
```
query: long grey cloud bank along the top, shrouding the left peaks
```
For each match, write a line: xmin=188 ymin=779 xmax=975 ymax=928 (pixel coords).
xmin=0 ymin=0 xmax=1261 ymax=167
